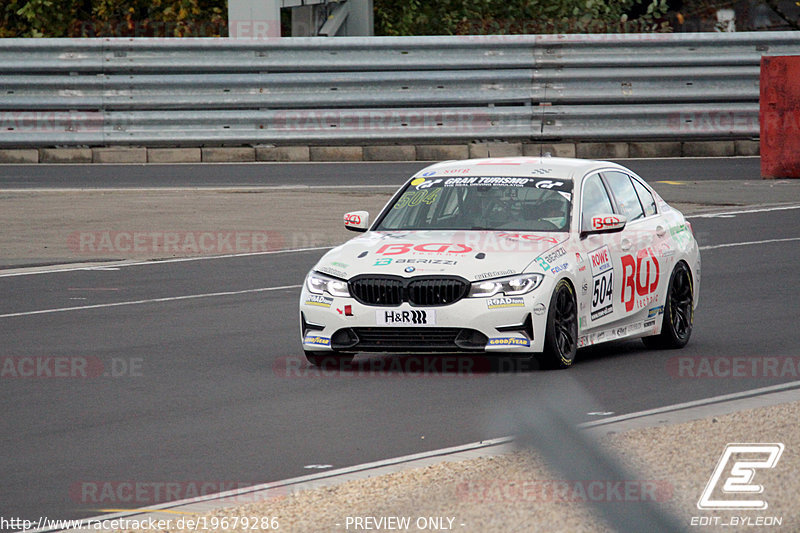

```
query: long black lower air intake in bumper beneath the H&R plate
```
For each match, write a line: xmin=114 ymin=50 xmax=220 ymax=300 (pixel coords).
xmin=332 ymin=327 xmax=489 ymax=352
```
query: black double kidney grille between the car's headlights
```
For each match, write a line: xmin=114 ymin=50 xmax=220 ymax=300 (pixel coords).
xmin=349 ymin=276 xmax=469 ymax=307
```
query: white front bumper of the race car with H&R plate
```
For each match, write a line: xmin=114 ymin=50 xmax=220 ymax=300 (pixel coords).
xmin=300 ymin=287 xmax=549 ymax=353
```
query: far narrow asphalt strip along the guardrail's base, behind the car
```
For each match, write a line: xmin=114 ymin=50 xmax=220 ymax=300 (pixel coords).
xmin=0 ymin=157 xmax=761 ymax=189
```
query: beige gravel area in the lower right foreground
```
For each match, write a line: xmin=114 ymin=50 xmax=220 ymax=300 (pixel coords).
xmin=117 ymin=402 xmax=800 ymax=533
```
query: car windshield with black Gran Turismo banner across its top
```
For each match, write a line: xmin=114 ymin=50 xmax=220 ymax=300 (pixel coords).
xmin=376 ymin=176 xmax=572 ymax=231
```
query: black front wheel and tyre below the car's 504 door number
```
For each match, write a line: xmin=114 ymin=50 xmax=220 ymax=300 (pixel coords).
xmin=537 ymin=279 xmax=578 ymax=369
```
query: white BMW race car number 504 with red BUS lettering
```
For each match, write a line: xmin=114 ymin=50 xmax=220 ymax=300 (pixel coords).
xmin=300 ymin=157 xmax=700 ymax=368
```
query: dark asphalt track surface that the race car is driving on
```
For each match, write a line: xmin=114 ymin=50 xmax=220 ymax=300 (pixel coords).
xmin=0 ymin=157 xmax=800 ymax=520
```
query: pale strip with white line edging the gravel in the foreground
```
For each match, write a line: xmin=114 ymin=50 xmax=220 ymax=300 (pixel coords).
xmin=42 ymin=381 xmax=800 ymax=533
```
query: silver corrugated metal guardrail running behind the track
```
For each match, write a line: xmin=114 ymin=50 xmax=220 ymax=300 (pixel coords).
xmin=0 ymin=32 xmax=800 ymax=147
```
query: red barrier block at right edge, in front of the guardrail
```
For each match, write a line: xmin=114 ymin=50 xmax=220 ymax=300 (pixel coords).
xmin=760 ymin=56 xmax=800 ymax=178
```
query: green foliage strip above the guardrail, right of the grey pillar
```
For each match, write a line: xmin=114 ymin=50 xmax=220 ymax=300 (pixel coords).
xmin=375 ymin=0 xmax=668 ymax=35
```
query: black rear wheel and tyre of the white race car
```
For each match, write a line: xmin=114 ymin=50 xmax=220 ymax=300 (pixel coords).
xmin=642 ymin=262 xmax=694 ymax=350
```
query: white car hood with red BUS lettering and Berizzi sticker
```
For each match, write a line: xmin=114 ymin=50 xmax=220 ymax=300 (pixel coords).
xmin=314 ymin=231 xmax=569 ymax=281
